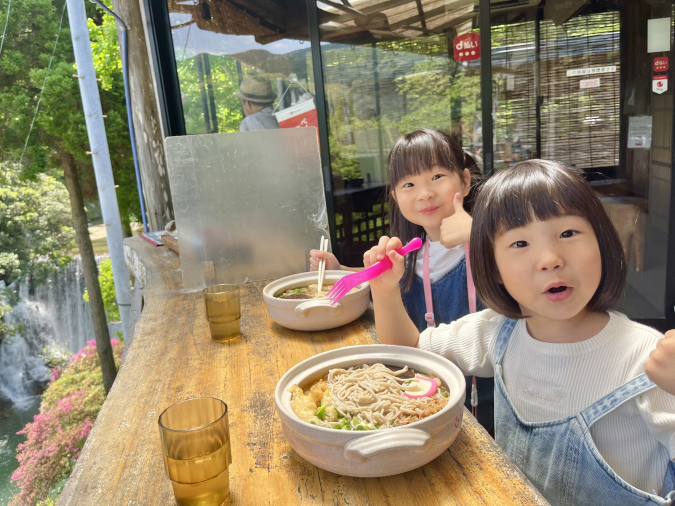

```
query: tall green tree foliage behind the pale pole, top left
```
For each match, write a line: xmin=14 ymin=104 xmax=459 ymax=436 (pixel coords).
xmin=0 ymin=0 xmax=140 ymax=231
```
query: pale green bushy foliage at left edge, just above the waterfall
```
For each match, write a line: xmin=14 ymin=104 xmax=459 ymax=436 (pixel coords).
xmin=0 ymin=163 xmax=74 ymax=285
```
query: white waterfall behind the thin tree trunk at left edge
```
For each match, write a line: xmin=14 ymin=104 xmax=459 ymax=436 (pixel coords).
xmin=0 ymin=256 xmax=121 ymax=410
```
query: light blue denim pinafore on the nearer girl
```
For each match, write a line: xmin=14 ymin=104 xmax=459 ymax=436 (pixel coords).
xmin=495 ymin=319 xmax=675 ymax=506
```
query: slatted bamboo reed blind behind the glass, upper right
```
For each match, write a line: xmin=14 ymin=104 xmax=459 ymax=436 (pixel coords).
xmin=492 ymin=12 xmax=621 ymax=169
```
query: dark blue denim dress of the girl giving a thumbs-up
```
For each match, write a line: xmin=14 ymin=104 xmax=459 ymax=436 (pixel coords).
xmin=401 ymin=259 xmax=494 ymax=432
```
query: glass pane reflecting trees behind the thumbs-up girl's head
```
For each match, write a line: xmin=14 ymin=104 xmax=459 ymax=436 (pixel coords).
xmin=317 ymin=0 xmax=482 ymax=260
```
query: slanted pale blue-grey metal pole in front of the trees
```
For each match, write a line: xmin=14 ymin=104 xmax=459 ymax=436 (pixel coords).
xmin=67 ymin=0 xmax=131 ymax=336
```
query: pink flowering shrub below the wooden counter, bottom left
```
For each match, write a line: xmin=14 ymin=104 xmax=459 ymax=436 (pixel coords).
xmin=10 ymin=339 xmax=123 ymax=506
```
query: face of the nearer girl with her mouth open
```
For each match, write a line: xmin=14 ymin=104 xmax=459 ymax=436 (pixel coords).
xmin=495 ymin=215 xmax=602 ymax=320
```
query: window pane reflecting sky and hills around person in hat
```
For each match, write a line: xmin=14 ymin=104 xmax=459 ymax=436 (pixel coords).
xmin=168 ymin=0 xmax=314 ymax=134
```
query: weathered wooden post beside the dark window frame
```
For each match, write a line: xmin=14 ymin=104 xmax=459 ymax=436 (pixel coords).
xmin=113 ymin=0 xmax=174 ymax=230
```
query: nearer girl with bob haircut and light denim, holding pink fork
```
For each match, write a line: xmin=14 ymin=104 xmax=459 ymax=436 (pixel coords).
xmin=364 ymin=160 xmax=675 ymax=506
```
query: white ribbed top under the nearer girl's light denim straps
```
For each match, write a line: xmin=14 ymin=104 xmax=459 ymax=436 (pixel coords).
xmin=419 ymin=309 xmax=675 ymax=493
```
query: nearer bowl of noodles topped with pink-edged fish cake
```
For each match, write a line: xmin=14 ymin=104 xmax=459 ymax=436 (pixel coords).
xmin=275 ymin=344 xmax=466 ymax=478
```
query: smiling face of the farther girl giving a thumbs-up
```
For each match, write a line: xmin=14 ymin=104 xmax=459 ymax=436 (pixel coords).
xmin=392 ymin=166 xmax=471 ymax=229
